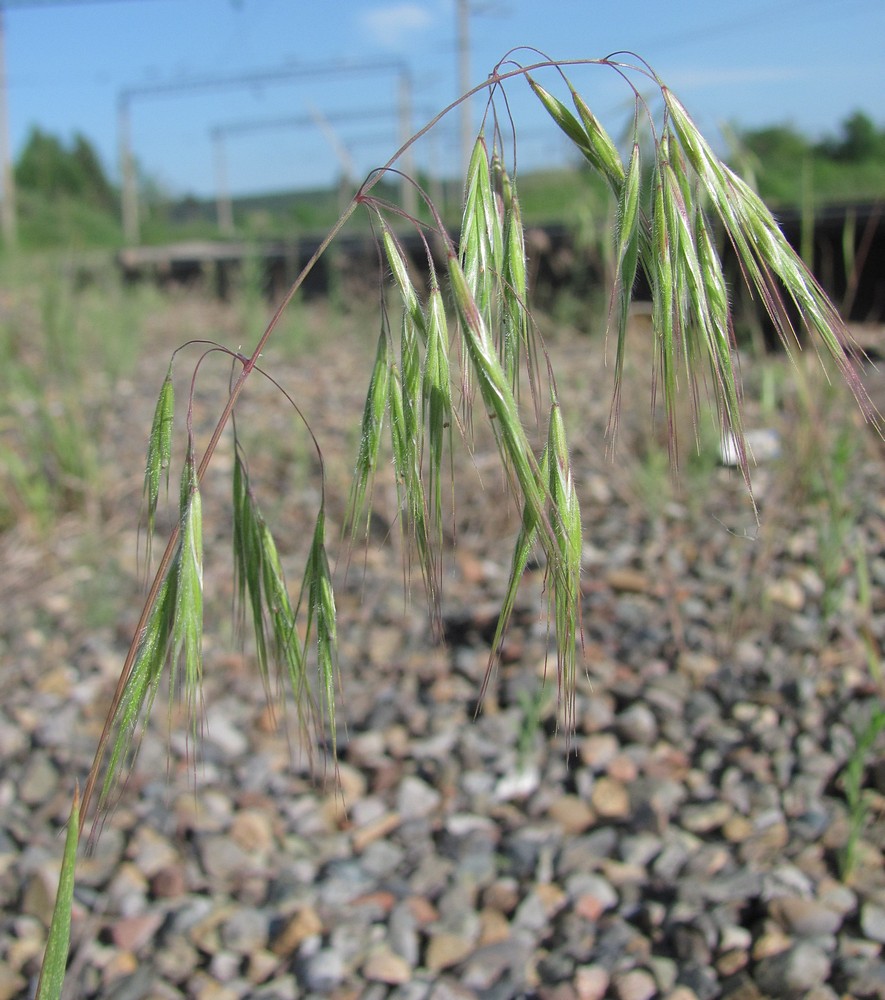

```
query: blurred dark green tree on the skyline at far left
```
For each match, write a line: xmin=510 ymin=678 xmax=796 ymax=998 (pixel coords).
xmin=15 ymin=127 xmax=115 ymax=209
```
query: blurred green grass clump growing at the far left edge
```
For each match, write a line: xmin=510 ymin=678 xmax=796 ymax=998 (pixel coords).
xmin=0 ymin=255 xmax=156 ymax=532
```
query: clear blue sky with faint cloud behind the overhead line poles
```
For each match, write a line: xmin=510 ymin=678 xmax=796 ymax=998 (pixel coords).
xmin=2 ymin=0 xmax=885 ymax=195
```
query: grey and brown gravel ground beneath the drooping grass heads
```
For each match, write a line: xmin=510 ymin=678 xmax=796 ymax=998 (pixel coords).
xmin=0 ymin=301 xmax=885 ymax=1000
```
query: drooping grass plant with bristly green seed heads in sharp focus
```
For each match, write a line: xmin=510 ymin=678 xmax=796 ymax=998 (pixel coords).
xmin=31 ymin=50 xmax=875 ymax=992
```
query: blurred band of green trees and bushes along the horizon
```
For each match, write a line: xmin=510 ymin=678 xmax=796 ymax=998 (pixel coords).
xmin=3 ymin=112 xmax=885 ymax=249
